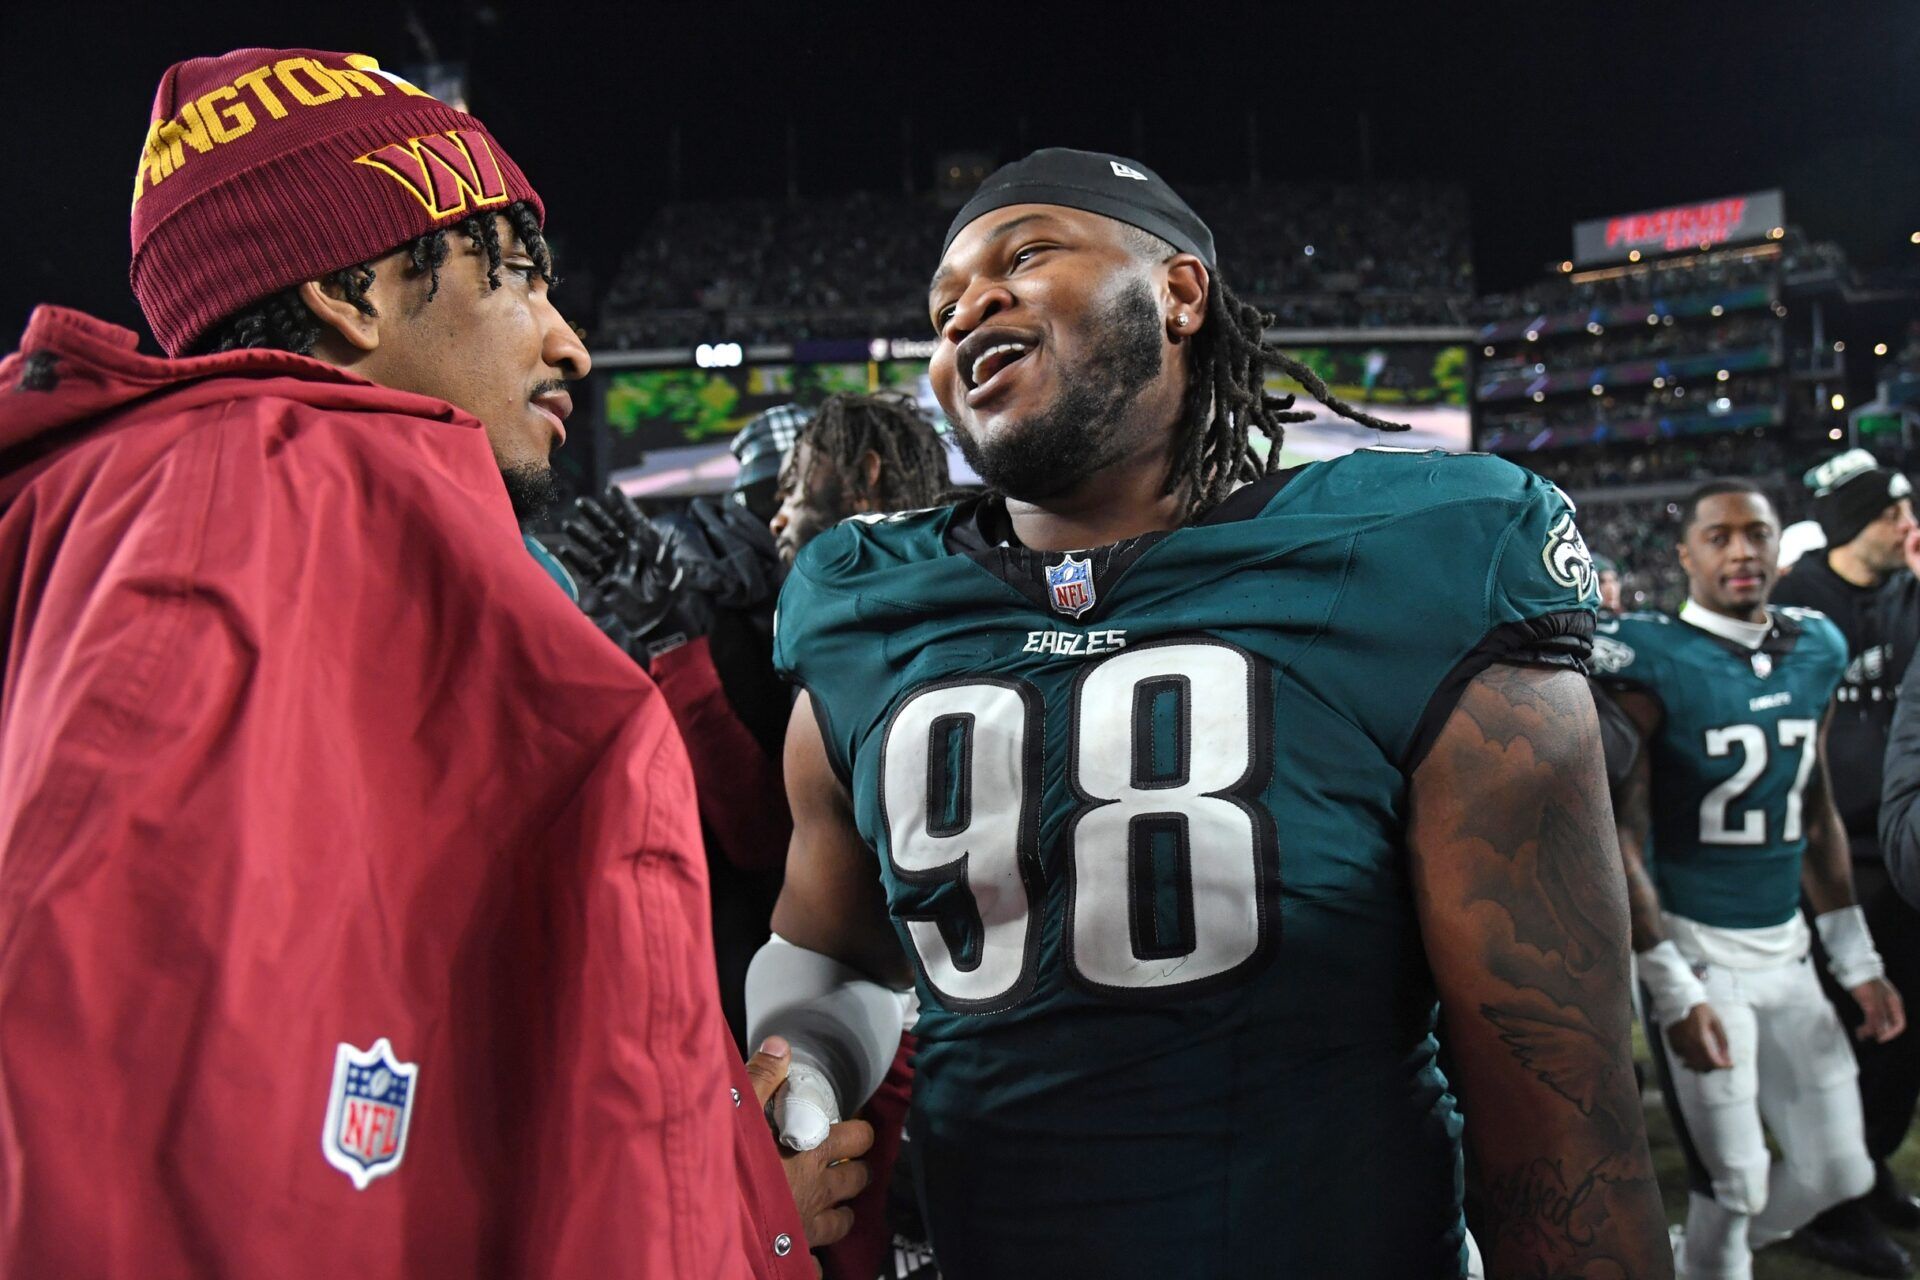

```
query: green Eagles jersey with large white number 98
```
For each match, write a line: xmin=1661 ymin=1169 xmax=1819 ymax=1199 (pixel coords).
xmin=776 ymin=451 xmax=1596 ymax=1280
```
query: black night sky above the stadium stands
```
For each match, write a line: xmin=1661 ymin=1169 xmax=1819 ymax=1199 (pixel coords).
xmin=0 ymin=0 xmax=1920 ymax=345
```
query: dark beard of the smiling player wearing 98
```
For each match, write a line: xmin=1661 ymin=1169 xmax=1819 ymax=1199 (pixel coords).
xmin=954 ymin=280 xmax=1165 ymax=503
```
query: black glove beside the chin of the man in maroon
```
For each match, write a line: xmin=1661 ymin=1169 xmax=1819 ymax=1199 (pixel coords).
xmin=559 ymin=486 xmax=712 ymax=664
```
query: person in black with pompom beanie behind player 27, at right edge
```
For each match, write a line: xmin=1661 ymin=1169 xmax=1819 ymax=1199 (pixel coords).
xmin=1774 ymin=449 xmax=1920 ymax=1274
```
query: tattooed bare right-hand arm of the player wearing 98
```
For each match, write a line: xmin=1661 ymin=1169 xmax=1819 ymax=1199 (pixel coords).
xmin=1407 ymin=666 xmax=1672 ymax=1280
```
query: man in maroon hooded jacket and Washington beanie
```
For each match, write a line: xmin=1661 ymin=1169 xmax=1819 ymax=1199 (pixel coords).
xmin=0 ymin=50 xmax=864 ymax=1280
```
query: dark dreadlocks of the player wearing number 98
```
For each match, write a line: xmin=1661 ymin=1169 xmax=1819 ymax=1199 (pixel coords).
xmin=1129 ymin=228 xmax=1407 ymax=522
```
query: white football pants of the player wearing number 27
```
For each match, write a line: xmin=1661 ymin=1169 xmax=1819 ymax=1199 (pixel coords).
xmin=1661 ymin=958 xmax=1874 ymax=1280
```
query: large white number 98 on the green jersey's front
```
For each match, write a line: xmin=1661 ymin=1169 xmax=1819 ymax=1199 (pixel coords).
xmin=879 ymin=641 xmax=1279 ymax=1013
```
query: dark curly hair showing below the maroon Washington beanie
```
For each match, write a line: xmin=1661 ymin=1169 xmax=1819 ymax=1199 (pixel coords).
xmin=194 ymin=200 xmax=557 ymax=355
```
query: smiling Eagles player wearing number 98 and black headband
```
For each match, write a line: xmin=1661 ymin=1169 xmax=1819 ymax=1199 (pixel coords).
xmin=749 ymin=152 xmax=1667 ymax=1280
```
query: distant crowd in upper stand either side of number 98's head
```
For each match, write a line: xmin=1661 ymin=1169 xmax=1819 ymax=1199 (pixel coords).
xmin=595 ymin=182 xmax=1473 ymax=349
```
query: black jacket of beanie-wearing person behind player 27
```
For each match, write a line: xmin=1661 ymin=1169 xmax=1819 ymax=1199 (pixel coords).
xmin=1772 ymin=555 xmax=1920 ymax=858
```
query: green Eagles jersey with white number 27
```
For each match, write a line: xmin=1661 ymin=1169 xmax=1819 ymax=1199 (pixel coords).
xmin=1594 ymin=604 xmax=1847 ymax=929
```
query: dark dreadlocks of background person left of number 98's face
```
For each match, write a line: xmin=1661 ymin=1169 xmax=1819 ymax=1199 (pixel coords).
xmin=780 ymin=391 xmax=947 ymax=510
